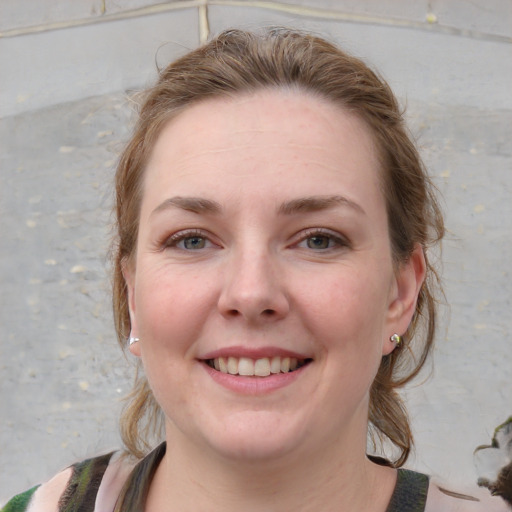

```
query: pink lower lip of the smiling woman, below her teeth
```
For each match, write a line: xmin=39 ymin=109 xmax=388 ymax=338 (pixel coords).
xmin=201 ymin=363 xmax=311 ymax=395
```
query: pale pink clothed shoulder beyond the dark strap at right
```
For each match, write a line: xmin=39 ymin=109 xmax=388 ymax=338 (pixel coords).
xmin=425 ymin=480 xmax=512 ymax=512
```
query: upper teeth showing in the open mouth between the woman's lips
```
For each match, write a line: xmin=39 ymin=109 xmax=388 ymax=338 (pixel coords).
xmin=204 ymin=356 xmax=313 ymax=377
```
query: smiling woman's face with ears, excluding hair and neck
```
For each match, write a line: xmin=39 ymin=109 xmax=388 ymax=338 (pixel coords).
xmin=125 ymin=90 xmax=423 ymax=459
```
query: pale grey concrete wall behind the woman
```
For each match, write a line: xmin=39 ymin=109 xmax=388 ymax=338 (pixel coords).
xmin=0 ymin=0 xmax=512 ymax=503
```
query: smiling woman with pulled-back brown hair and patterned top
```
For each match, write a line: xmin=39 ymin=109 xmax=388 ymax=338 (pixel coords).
xmin=5 ymin=30 xmax=505 ymax=512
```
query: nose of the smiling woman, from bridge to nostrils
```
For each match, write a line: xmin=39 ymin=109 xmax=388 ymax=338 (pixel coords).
xmin=218 ymin=246 xmax=290 ymax=323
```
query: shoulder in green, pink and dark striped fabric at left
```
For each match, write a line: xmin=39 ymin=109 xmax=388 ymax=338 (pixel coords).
xmin=0 ymin=453 xmax=133 ymax=512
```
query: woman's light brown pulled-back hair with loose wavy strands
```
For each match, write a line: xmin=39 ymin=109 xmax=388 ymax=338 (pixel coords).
xmin=113 ymin=28 xmax=444 ymax=467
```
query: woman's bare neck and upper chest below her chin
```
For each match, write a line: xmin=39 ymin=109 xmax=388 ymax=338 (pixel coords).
xmin=146 ymin=426 xmax=396 ymax=512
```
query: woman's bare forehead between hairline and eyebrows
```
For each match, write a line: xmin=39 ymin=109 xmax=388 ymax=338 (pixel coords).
xmin=145 ymin=89 xmax=380 ymax=205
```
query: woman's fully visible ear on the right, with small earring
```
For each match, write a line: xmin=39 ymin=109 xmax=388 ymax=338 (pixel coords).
xmin=382 ymin=244 xmax=427 ymax=355
